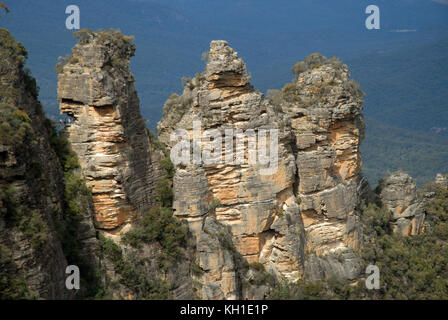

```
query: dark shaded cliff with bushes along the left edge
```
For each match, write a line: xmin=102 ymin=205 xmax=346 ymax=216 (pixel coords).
xmin=0 ymin=29 xmax=73 ymax=299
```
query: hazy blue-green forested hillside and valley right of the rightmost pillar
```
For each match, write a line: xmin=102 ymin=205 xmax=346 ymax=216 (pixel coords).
xmin=347 ymin=38 xmax=448 ymax=185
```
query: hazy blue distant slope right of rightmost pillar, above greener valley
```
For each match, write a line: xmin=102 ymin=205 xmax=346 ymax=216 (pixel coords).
xmin=346 ymin=37 xmax=448 ymax=136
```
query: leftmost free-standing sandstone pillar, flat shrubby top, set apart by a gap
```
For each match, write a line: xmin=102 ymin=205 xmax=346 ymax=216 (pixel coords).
xmin=58 ymin=31 xmax=154 ymax=230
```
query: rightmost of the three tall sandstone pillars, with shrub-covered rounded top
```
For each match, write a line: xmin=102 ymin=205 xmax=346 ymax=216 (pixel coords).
xmin=282 ymin=54 xmax=366 ymax=279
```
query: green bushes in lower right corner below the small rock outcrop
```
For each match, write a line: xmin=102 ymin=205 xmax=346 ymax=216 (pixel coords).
xmin=361 ymin=184 xmax=448 ymax=299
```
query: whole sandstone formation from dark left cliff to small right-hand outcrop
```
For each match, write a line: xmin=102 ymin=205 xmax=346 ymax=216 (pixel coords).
xmin=0 ymin=23 xmax=440 ymax=299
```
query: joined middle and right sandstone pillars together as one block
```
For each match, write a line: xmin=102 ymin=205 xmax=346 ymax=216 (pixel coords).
xmin=158 ymin=41 xmax=364 ymax=298
